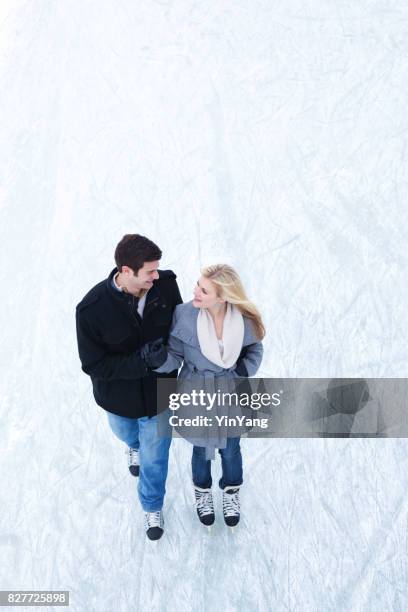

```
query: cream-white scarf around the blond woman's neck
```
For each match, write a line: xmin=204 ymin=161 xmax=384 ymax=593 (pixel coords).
xmin=197 ymin=302 xmax=245 ymax=368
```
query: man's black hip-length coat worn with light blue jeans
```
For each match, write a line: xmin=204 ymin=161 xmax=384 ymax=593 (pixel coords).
xmin=76 ymin=268 xmax=183 ymax=418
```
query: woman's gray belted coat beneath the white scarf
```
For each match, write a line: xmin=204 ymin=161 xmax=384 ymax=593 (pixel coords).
xmin=156 ymin=301 xmax=263 ymax=459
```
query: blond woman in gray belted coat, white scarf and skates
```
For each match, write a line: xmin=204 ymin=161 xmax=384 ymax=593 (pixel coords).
xmin=156 ymin=264 xmax=265 ymax=527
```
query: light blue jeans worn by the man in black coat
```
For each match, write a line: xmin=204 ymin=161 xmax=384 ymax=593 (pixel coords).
xmin=107 ymin=411 xmax=171 ymax=512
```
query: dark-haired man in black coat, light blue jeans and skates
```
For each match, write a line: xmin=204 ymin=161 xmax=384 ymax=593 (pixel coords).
xmin=76 ymin=234 xmax=182 ymax=540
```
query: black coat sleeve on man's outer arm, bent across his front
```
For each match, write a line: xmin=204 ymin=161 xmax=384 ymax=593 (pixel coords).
xmin=76 ymin=309 xmax=149 ymax=380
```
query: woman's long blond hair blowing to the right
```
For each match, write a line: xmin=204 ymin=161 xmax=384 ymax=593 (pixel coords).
xmin=201 ymin=264 xmax=266 ymax=340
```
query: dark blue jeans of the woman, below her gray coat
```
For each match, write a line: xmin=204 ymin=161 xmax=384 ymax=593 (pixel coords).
xmin=191 ymin=437 xmax=242 ymax=489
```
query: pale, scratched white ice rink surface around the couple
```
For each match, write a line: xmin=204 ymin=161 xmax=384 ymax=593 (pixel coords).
xmin=0 ymin=0 xmax=408 ymax=612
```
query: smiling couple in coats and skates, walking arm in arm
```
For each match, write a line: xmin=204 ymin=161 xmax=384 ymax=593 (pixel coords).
xmin=76 ymin=234 xmax=265 ymax=540
